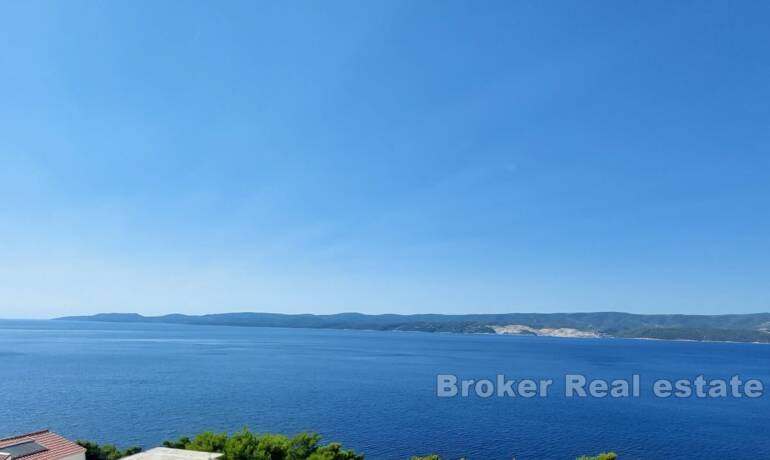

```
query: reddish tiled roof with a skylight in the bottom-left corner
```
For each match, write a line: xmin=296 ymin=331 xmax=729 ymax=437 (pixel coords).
xmin=0 ymin=430 xmax=86 ymax=460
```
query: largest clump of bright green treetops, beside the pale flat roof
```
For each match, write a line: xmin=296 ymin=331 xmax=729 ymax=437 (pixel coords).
xmin=160 ymin=428 xmax=364 ymax=460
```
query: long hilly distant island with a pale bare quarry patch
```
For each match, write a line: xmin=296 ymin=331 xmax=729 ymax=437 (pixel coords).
xmin=57 ymin=312 xmax=770 ymax=343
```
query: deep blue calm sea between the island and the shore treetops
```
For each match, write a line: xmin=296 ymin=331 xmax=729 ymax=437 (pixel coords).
xmin=0 ymin=320 xmax=770 ymax=460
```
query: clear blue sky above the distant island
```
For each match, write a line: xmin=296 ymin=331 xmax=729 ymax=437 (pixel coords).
xmin=0 ymin=0 xmax=770 ymax=318
